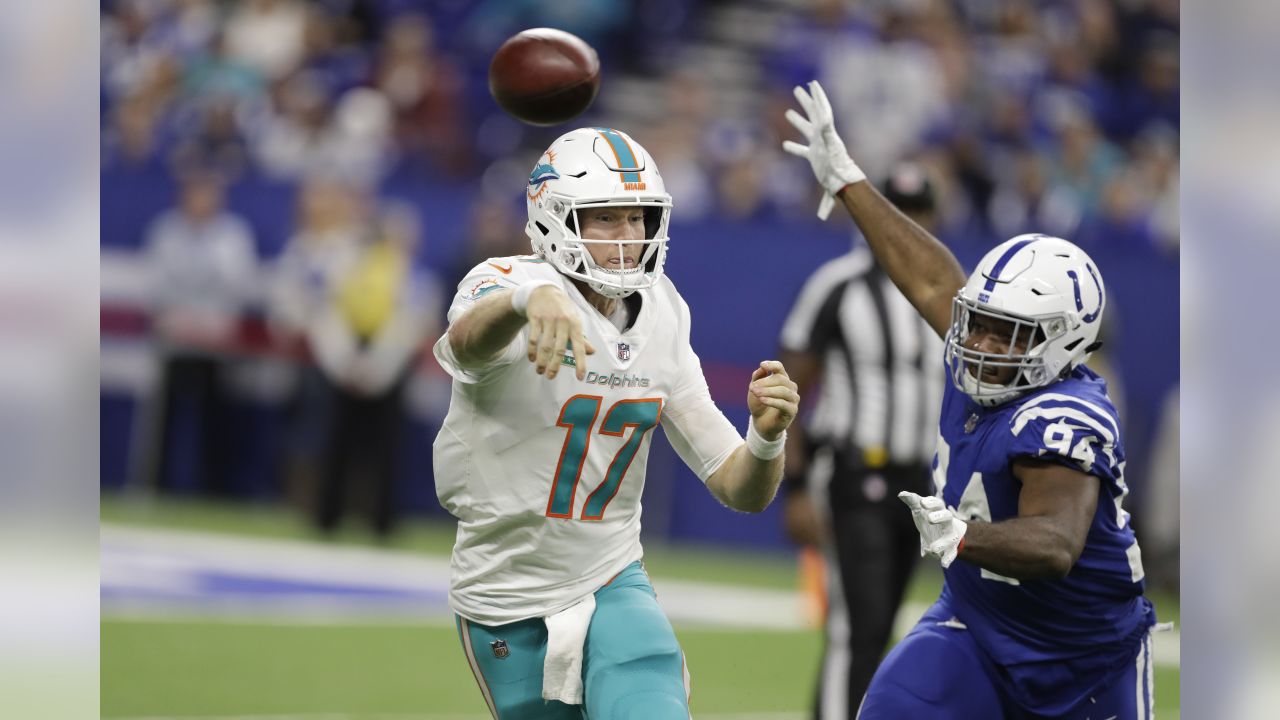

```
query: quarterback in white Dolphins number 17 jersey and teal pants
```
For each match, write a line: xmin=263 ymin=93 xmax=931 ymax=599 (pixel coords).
xmin=434 ymin=128 xmax=799 ymax=717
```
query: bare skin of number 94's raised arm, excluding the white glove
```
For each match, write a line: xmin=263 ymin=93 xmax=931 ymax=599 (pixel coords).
xmin=840 ymin=182 xmax=965 ymax=336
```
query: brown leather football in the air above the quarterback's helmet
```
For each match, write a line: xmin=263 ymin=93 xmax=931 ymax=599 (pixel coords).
xmin=489 ymin=27 xmax=600 ymax=126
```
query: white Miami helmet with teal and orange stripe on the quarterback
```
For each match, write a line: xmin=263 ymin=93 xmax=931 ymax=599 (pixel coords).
xmin=525 ymin=128 xmax=671 ymax=297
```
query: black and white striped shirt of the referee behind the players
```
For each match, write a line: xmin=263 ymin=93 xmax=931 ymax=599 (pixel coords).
xmin=781 ymin=247 xmax=943 ymax=464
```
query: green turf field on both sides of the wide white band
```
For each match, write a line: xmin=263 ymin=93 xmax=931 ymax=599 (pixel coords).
xmin=101 ymin=497 xmax=1179 ymax=720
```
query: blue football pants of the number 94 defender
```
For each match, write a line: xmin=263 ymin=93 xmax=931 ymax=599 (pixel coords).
xmin=858 ymin=597 xmax=1155 ymax=720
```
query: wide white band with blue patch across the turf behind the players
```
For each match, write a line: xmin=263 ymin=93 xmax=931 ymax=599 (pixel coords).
xmin=101 ymin=524 xmax=1181 ymax=666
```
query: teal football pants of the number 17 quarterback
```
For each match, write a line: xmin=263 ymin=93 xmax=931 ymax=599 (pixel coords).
xmin=456 ymin=562 xmax=689 ymax=720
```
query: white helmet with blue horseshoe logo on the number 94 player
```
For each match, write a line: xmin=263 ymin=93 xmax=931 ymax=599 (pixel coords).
xmin=946 ymin=234 xmax=1106 ymax=407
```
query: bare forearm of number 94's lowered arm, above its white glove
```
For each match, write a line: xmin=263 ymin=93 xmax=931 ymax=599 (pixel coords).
xmin=959 ymin=516 xmax=1083 ymax=580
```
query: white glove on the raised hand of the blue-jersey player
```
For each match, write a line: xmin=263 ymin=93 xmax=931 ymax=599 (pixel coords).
xmin=782 ymin=81 xmax=867 ymax=220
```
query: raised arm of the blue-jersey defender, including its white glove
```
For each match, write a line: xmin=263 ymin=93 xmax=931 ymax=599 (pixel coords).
xmin=782 ymin=81 xmax=965 ymax=336
